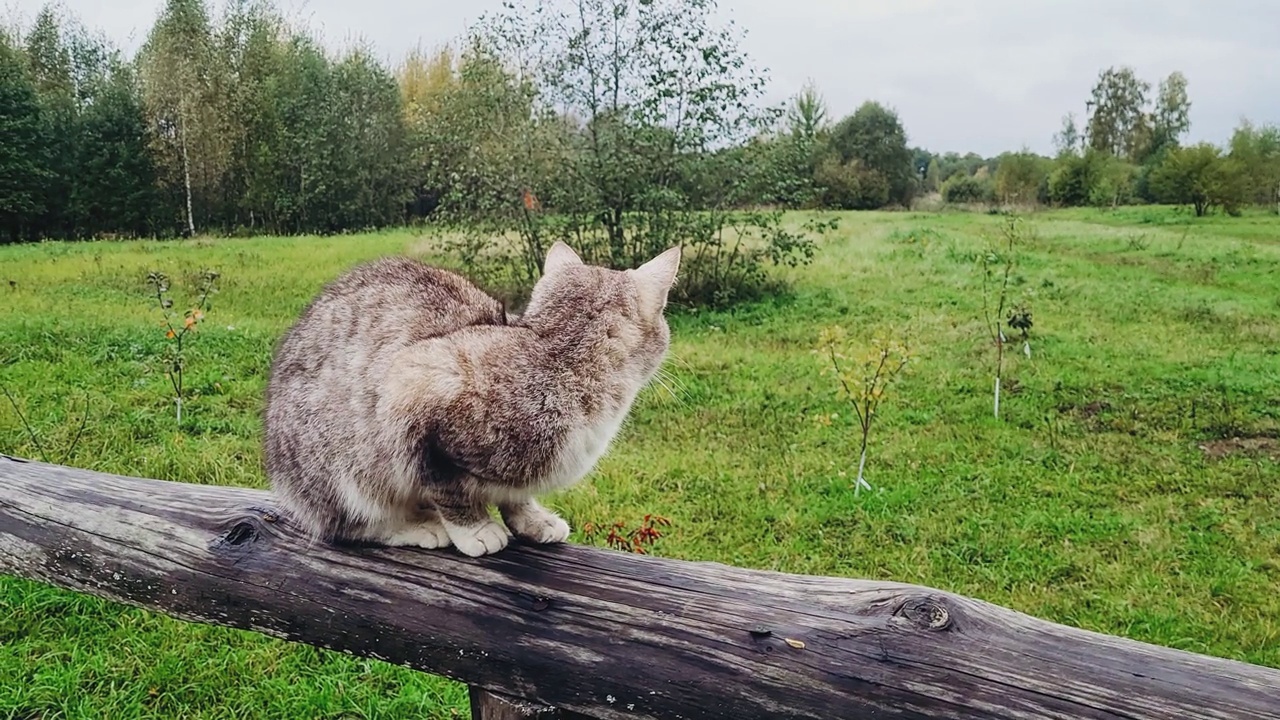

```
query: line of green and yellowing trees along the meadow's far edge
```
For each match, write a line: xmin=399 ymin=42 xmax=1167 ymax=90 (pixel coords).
xmin=0 ymin=0 xmax=1280 ymax=248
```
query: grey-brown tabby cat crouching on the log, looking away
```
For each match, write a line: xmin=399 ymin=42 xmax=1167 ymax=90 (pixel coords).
xmin=264 ymin=242 xmax=681 ymax=557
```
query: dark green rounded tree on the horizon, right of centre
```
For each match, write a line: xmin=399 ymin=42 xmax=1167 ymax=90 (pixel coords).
xmin=831 ymin=101 xmax=915 ymax=205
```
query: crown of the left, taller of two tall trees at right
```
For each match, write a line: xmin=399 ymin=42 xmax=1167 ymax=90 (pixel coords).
xmin=1088 ymin=67 xmax=1151 ymax=160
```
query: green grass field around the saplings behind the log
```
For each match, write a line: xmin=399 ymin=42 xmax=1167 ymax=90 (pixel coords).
xmin=0 ymin=209 xmax=1280 ymax=720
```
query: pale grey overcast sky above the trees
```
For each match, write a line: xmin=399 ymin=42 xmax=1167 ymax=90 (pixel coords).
xmin=6 ymin=0 xmax=1280 ymax=155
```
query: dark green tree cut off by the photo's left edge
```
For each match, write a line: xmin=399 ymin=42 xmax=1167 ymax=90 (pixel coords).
xmin=0 ymin=33 xmax=47 ymax=242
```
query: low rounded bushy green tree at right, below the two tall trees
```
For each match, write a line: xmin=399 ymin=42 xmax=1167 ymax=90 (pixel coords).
xmin=1151 ymin=142 xmax=1244 ymax=217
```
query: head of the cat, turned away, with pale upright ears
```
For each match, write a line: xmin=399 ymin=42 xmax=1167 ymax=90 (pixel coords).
xmin=522 ymin=242 xmax=680 ymax=382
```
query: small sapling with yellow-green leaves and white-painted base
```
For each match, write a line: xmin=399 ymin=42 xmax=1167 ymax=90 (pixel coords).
xmin=818 ymin=325 xmax=911 ymax=495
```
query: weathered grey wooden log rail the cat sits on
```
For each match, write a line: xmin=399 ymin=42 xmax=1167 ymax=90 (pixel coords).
xmin=0 ymin=457 xmax=1280 ymax=720
